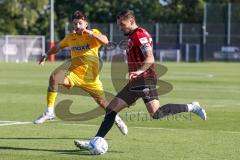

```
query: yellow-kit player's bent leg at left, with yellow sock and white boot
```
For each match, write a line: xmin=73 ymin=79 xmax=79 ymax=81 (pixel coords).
xmin=34 ymin=70 xmax=71 ymax=124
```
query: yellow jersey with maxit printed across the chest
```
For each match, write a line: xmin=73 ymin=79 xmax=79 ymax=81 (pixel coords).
xmin=59 ymin=29 xmax=102 ymax=82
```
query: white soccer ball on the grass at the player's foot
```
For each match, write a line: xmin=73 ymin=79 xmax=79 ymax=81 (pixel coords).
xmin=89 ymin=137 xmax=108 ymax=155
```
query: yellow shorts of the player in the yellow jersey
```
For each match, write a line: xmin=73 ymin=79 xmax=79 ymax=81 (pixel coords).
xmin=67 ymin=72 xmax=104 ymax=98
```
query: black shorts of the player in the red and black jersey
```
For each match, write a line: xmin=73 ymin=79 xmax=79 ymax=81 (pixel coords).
xmin=116 ymin=78 xmax=158 ymax=106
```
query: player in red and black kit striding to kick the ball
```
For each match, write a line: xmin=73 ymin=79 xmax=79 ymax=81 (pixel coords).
xmin=75 ymin=10 xmax=207 ymax=149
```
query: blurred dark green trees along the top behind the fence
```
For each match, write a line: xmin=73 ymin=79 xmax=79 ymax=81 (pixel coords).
xmin=0 ymin=0 xmax=236 ymax=40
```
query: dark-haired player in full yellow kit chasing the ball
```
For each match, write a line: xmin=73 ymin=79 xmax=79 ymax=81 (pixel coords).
xmin=34 ymin=11 xmax=128 ymax=135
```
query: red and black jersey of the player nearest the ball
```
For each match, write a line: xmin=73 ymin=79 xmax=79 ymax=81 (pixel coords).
xmin=127 ymin=27 xmax=156 ymax=78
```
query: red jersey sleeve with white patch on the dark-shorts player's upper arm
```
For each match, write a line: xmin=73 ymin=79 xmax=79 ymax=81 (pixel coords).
xmin=136 ymin=31 xmax=153 ymax=54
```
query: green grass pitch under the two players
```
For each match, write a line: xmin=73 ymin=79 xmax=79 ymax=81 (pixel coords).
xmin=0 ymin=62 xmax=240 ymax=160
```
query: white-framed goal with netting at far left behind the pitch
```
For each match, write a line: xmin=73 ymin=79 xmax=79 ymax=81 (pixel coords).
xmin=0 ymin=35 xmax=45 ymax=63
